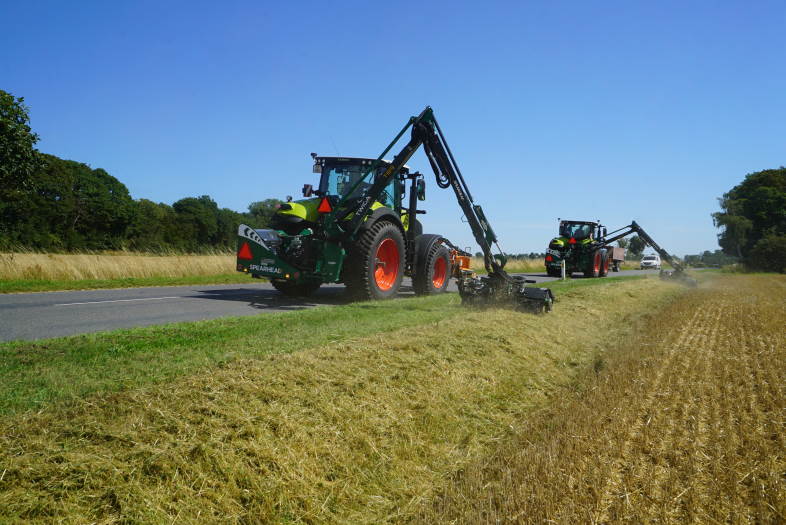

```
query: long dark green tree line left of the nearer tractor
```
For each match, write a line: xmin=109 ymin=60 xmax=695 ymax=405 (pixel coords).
xmin=0 ymin=90 xmax=280 ymax=252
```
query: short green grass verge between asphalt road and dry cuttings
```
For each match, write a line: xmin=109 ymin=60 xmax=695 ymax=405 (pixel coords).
xmin=0 ymin=276 xmax=630 ymax=414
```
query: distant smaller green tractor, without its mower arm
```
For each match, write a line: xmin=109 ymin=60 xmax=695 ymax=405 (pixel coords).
xmin=544 ymin=220 xmax=624 ymax=277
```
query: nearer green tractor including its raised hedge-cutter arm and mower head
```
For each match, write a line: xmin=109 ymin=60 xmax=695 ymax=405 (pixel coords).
xmin=237 ymin=107 xmax=553 ymax=310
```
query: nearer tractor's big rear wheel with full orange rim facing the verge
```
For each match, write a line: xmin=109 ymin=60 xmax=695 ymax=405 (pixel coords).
xmin=344 ymin=221 xmax=405 ymax=300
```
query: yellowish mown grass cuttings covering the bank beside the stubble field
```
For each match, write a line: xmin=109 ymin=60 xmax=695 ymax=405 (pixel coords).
xmin=0 ymin=279 xmax=685 ymax=523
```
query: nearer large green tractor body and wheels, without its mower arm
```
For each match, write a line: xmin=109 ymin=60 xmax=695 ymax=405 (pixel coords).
xmin=238 ymin=154 xmax=452 ymax=299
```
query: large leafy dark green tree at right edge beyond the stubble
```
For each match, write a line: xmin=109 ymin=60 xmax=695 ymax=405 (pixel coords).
xmin=712 ymin=167 xmax=786 ymax=271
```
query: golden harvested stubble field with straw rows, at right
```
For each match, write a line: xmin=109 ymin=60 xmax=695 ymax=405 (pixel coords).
xmin=418 ymin=275 xmax=786 ymax=523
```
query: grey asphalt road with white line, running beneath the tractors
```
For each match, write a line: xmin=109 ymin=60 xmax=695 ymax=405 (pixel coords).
xmin=0 ymin=270 xmax=657 ymax=341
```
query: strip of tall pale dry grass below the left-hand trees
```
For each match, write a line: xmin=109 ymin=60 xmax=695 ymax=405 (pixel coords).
xmin=0 ymin=252 xmax=235 ymax=281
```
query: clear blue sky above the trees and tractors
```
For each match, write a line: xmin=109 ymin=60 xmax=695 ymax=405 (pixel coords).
xmin=0 ymin=0 xmax=786 ymax=255
